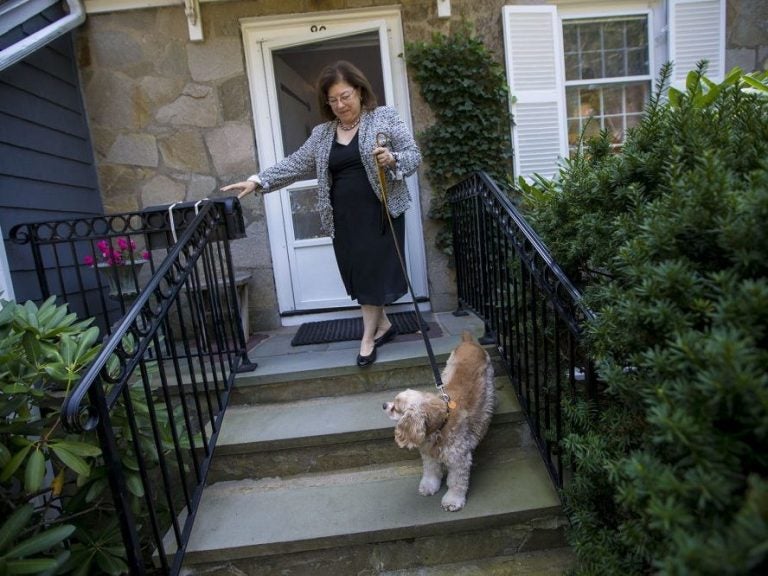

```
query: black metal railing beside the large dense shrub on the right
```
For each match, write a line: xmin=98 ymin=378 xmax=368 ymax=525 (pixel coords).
xmin=449 ymin=173 xmax=598 ymax=487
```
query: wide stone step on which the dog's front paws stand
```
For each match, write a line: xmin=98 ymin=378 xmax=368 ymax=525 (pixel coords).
xmin=178 ymin=448 xmax=565 ymax=576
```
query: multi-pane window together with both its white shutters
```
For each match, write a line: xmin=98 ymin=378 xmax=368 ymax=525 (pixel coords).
xmin=502 ymin=0 xmax=726 ymax=179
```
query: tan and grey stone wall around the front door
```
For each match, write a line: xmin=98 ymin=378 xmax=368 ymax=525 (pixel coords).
xmin=77 ymin=0 xmax=768 ymax=330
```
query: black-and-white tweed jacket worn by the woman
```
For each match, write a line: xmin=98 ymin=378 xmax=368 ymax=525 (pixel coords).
xmin=249 ymin=106 xmax=421 ymax=237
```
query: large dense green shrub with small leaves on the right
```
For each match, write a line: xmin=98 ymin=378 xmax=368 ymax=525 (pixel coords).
xmin=524 ymin=65 xmax=768 ymax=575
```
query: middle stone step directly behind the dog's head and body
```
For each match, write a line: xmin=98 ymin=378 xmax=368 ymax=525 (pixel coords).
xmin=208 ymin=373 xmax=531 ymax=484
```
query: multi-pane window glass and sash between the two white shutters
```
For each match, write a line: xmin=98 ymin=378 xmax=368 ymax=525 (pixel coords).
xmin=563 ymin=15 xmax=651 ymax=151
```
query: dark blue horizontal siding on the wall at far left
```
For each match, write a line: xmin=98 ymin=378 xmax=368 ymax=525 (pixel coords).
xmin=0 ymin=6 xmax=103 ymax=301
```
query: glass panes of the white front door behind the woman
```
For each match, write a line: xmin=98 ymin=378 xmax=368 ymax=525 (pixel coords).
xmin=272 ymin=30 xmax=385 ymax=240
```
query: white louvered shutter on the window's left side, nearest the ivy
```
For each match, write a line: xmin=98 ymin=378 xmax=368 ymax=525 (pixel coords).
xmin=502 ymin=6 xmax=568 ymax=178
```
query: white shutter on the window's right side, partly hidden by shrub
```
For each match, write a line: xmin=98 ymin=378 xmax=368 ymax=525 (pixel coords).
xmin=669 ymin=0 xmax=725 ymax=85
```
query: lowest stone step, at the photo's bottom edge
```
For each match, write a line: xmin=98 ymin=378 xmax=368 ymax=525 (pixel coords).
xmin=380 ymin=547 xmax=575 ymax=576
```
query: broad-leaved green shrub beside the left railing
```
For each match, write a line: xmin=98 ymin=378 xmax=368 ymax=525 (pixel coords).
xmin=0 ymin=297 xmax=160 ymax=575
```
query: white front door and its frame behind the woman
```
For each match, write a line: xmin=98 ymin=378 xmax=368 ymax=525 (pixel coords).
xmin=243 ymin=10 xmax=427 ymax=314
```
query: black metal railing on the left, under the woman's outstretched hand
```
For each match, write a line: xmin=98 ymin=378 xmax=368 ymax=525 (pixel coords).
xmin=11 ymin=198 xmax=255 ymax=574
